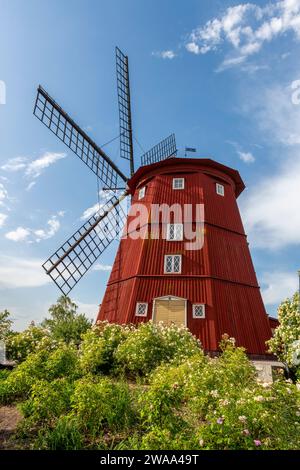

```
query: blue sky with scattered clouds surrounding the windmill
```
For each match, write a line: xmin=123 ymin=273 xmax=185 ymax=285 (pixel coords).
xmin=0 ymin=0 xmax=300 ymax=328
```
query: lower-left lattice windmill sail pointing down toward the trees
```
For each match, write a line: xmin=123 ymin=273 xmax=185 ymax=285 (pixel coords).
xmin=43 ymin=192 xmax=127 ymax=295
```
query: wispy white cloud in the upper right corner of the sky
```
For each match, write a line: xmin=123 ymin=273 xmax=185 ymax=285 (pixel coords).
xmin=185 ymin=0 xmax=300 ymax=71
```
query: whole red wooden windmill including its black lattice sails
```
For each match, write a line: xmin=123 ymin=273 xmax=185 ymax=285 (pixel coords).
xmin=34 ymin=48 xmax=271 ymax=355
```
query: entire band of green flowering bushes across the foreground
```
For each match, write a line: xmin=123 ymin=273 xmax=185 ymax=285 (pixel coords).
xmin=0 ymin=322 xmax=300 ymax=450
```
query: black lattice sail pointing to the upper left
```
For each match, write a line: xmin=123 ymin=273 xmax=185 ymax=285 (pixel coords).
xmin=34 ymin=86 xmax=127 ymax=189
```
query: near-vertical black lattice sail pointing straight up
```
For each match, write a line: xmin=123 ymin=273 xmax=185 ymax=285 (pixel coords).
xmin=116 ymin=47 xmax=134 ymax=176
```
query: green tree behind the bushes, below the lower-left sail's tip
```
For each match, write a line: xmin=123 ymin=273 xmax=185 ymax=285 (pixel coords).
xmin=42 ymin=296 xmax=92 ymax=344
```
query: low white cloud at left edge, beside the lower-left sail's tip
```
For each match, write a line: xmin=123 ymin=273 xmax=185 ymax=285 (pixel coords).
xmin=0 ymin=255 xmax=51 ymax=289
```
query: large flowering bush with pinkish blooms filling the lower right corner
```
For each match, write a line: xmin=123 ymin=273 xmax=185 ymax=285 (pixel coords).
xmin=136 ymin=347 xmax=300 ymax=449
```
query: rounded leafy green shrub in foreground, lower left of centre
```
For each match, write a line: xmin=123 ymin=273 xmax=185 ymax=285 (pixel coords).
xmin=71 ymin=377 xmax=133 ymax=436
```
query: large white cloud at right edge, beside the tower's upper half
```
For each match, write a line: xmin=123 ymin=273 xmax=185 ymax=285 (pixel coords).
xmin=241 ymin=155 xmax=300 ymax=249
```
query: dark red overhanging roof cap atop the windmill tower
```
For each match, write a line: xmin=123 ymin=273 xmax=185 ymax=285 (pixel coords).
xmin=127 ymin=157 xmax=245 ymax=197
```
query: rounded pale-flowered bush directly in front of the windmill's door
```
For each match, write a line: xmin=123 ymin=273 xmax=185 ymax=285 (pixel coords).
xmin=115 ymin=322 xmax=200 ymax=376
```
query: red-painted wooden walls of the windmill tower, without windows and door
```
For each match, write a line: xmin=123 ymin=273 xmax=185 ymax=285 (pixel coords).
xmin=98 ymin=159 xmax=271 ymax=354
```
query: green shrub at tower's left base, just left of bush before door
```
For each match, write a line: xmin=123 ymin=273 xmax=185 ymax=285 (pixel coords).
xmin=80 ymin=322 xmax=130 ymax=374
